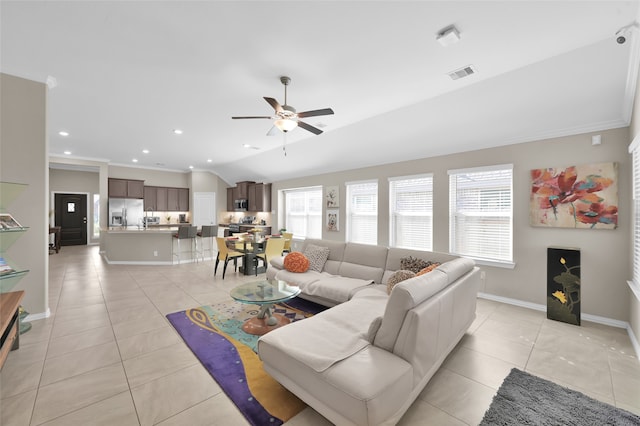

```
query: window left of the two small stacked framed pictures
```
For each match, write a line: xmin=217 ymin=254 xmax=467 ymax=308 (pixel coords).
xmin=284 ymin=186 xmax=322 ymax=238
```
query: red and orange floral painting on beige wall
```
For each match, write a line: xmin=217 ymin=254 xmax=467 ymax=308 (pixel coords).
xmin=529 ymin=163 xmax=618 ymax=229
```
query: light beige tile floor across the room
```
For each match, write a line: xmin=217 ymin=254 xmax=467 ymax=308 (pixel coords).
xmin=0 ymin=246 xmax=640 ymax=426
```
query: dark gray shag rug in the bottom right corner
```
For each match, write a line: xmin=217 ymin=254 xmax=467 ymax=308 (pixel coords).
xmin=480 ymin=368 xmax=640 ymax=426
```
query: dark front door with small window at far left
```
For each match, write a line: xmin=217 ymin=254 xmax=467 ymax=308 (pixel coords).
xmin=55 ymin=194 xmax=87 ymax=246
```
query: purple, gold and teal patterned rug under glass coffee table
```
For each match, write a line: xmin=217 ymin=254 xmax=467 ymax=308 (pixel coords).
xmin=167 ymin=298 xmax=327 ymax=426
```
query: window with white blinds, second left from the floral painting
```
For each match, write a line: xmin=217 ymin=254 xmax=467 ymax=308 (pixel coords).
xmin=389 ymin=174 xmax=433 ymax=251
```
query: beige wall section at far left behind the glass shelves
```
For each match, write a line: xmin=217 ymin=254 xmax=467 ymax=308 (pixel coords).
xmin=0 ymin=73 xmax=49 ymax=317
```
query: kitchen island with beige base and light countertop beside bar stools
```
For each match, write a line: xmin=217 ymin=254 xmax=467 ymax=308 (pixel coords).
xmin=100 ymin=225 xmax=184 ymax=265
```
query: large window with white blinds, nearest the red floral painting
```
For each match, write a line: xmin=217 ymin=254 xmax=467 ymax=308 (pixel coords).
xmin=449 ymin=164 xmax=513 ymax=263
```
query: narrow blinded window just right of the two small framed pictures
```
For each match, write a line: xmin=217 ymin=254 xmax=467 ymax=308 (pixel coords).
xmin=346 ymin=181 xmax=378 ymax=244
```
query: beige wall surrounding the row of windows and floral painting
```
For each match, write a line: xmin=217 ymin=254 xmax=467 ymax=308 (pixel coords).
xmin=272 ymin=128 xmax=631 ymax=321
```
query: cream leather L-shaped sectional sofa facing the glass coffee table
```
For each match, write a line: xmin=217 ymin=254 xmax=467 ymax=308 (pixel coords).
xmin=258 ymin=240 xmax=480 ymax=425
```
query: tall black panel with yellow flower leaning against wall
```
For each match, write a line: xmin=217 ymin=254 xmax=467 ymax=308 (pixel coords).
xmin=547 ymin=247 xmax=580 ymax=325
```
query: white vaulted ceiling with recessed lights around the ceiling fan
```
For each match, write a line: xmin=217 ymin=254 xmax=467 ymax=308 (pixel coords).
xmin=0 ymin=0 xmax=640 ymax=183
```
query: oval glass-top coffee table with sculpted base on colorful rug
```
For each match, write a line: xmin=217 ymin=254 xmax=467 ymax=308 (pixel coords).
xmin=231 ymin=280 xmax=300 ymax=336
